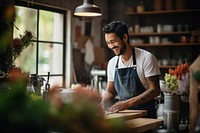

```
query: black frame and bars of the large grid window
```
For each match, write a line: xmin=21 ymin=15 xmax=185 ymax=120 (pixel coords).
xmin=15 ymin=1 xmax=70 ymax=87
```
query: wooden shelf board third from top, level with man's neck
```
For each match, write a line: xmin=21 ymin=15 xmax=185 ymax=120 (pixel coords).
xmin=131 ymin=43 xmax=200 ymax=47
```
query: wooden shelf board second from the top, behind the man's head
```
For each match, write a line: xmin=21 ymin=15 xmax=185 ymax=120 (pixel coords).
xmin=129 ymin=31 xmax=192 ymax=36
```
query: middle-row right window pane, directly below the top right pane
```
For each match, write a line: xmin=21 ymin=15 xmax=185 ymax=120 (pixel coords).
xmin=38 ymin=43 xmax=63 ymax=75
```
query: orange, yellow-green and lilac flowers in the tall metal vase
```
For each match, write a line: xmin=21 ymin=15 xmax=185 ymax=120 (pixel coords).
xmin=161 ymin=63 xmax=189 ymax=96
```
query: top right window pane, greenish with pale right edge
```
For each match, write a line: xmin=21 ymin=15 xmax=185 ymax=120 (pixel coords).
xmin=39 ymin=10 xmax=63 ymax=42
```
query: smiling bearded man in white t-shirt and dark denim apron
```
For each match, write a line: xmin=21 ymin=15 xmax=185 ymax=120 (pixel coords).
xmin=101 ymin=20 xmax=160 ymax=118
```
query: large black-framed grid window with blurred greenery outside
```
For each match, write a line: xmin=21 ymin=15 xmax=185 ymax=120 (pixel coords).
xmin=13 ymin=4 xmax=66 ymax=87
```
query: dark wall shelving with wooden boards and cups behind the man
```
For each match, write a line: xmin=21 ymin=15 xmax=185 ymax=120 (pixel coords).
xmin=125 ymin=5 xmax=200 ymax=72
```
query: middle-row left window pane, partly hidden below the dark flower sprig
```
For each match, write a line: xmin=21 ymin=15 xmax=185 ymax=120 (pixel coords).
xmin=15 ymin=43 xmax=36 ymax=74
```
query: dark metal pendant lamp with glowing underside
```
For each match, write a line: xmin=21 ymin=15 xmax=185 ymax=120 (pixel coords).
xmin=74 ymin=0 xmax=102 ymax=17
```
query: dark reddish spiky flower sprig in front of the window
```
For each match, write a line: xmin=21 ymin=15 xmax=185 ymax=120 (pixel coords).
xmin=5 ymin=31 xmax=34 ymax=68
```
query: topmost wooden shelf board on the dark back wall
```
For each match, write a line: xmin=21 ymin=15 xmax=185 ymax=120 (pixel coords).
xmin=125 ymin=9 xmax=200 ymax=15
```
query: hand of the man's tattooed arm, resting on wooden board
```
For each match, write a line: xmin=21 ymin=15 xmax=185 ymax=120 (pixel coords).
xmin=110 ymin=101 xmax=129 ymax=113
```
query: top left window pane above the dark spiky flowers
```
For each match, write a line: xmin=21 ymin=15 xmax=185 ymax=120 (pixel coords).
xmin=14 ymin=6 xmax=37 ymax=38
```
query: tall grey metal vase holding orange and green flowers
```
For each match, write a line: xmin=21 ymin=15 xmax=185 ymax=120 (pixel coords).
xmin=164 ymin=93 xmax=181 ymax=131
